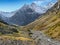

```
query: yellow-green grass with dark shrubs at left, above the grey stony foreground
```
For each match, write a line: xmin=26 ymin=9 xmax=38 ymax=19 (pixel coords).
xmin=0 ymin=22 xmax=33 ymax=41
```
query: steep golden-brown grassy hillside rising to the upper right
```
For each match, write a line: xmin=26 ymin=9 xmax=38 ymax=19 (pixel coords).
xmin=23 ymin=3 xmax=60 ymax=40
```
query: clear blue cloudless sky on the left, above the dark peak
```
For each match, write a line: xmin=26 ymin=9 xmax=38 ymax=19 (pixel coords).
xmin=0 ymin=0 xmax=32 ymax=12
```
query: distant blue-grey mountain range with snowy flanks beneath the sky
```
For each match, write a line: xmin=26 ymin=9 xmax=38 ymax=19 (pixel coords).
xmin=0 ymin=3 xmax=56 ymax=26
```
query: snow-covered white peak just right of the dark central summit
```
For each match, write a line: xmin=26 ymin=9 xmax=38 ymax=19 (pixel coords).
xmin=30 ymin=3 xmax=46 ymax=14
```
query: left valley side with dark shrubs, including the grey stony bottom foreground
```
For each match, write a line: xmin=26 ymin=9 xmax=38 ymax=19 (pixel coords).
xmin=0 ymin=20 xmax=35 ymax=45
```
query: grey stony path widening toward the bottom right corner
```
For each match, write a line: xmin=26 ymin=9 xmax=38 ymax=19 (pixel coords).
xmin=31 ymin=31 xmax=60 ymax=45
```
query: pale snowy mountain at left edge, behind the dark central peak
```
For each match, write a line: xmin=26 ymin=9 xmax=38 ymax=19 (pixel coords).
xmin=0 ymin=11 xmax=15 ymax=23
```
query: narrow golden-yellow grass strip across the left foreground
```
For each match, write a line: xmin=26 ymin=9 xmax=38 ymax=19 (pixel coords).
xmin=0 ymin=35 xmax=33 ymax=41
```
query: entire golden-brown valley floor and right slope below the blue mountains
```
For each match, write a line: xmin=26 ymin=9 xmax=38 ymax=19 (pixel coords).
xmin=0 ymin=3 xmax=60 ymax=45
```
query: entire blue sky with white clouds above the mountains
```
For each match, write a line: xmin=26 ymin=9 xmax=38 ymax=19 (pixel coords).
xmin=0 ymin=0 xmax=57 ymax=12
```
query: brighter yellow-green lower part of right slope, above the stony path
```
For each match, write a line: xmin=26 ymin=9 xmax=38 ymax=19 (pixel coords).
xmin=43 ymin=12 xmax=60 ymax=40
